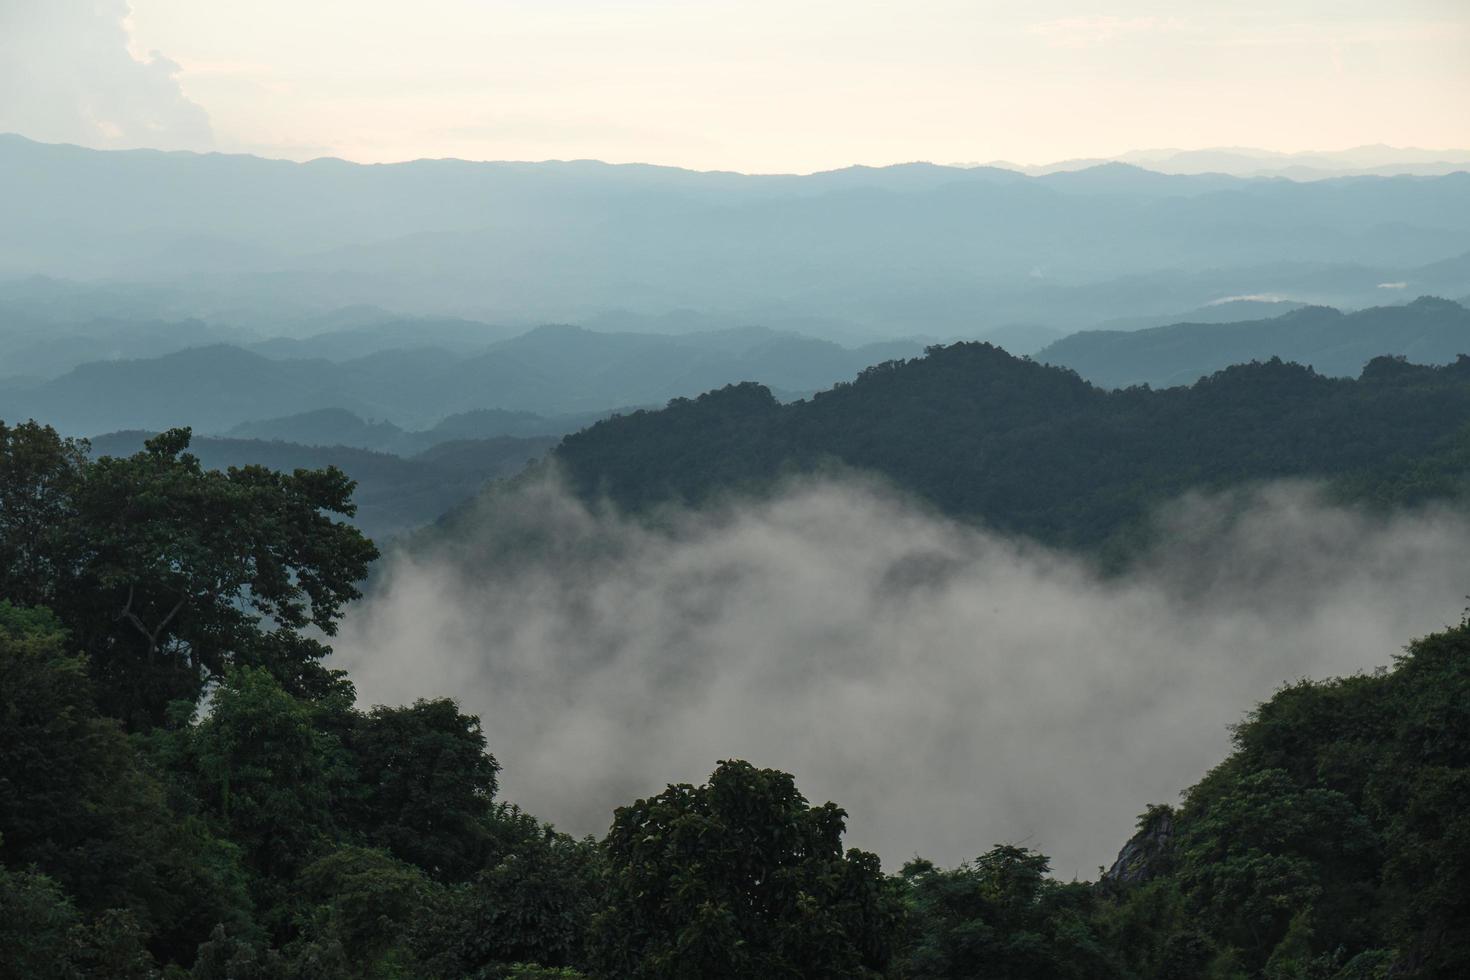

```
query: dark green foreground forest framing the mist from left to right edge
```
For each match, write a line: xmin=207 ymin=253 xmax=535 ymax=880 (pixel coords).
xmin=0 ymin=417 xmax=1470 ymax=980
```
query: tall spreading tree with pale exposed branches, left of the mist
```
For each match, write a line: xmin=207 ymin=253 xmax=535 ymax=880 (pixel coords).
xmin=73 ymin=429 xmax=376 ymax=726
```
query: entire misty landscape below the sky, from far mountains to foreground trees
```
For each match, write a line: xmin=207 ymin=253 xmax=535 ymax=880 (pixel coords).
xmin=0 ymin=138 xmax=1470 ymax=980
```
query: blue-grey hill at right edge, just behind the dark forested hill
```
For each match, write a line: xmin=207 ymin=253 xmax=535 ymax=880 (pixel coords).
xmin=1036 ymin=297 xmax=1470 ymax=388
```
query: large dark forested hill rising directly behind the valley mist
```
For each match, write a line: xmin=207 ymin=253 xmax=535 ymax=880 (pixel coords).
xmin=556 ymin=344 xmax=1470 ymax=547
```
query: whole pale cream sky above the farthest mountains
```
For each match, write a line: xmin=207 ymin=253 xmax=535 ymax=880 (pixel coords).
xmin=0 ymin=0 xmax=1470 ymax=172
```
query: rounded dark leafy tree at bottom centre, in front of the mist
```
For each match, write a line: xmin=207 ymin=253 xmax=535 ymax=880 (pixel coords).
xmin=589 ymin=761 xmax=901 ymax=979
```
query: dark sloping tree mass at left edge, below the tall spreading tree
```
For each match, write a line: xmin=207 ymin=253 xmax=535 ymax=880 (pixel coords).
xmin=0 ymin=601 xmax=253 ymax=956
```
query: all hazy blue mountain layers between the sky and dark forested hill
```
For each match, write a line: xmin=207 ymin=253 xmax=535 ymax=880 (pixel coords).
xmin=0 ymin=137 xmax=1470 ymax=552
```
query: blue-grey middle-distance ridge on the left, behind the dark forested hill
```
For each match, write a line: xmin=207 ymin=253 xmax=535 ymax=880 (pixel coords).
xmin=0 ymin=326 xmax=922 ymax=435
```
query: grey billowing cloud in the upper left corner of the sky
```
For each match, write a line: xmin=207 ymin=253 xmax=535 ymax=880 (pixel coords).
xmin=0 ymin=0 xmax=213 ymax=150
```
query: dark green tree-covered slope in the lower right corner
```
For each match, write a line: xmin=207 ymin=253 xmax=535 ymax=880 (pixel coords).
xmin=1078 ymin=623 xmax=1470 ymax=980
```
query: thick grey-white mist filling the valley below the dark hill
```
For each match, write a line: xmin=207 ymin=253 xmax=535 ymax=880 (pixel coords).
xmin=334 ymin=479 xmax=1470 ymax=879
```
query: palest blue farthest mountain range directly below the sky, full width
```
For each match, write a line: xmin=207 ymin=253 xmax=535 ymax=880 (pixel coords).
xmin=0 ymin=137 xmax=1470 ymax=347
